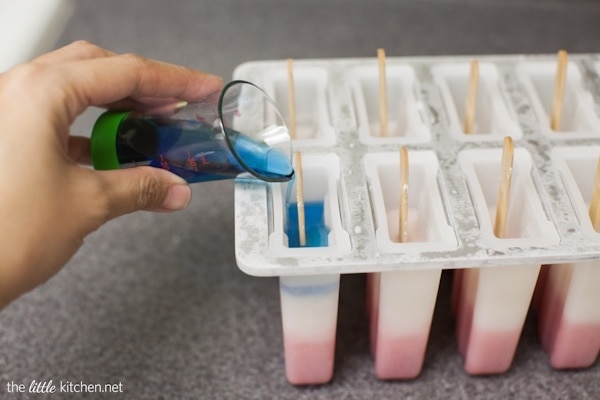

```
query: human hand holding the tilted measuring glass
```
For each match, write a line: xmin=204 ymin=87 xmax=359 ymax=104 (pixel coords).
xmin=0 ymin=42 xmax=223 ymax=309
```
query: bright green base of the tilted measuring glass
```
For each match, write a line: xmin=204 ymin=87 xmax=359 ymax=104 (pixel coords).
xmin=90 ymin=111 xmax=130 ymax=170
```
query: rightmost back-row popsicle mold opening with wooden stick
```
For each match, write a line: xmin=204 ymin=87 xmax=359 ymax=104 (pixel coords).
xmin=517 ymin=60 xmax=600 ymax=139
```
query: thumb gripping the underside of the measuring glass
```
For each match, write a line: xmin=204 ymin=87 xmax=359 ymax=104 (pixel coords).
xmin=98 ymin=167 xmax=192 ymax=219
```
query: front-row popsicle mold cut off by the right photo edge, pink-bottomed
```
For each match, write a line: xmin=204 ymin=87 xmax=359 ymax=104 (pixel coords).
xmin=538 ymin=146 xmax=600 ymax=369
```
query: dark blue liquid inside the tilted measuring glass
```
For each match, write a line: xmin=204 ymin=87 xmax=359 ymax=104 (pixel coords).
xmin=116 ymin=117 xmax=294 ymax=183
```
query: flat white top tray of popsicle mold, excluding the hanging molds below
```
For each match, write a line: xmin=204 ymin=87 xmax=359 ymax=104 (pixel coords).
xmin=234 ymin=54 xmax=600 ymax=276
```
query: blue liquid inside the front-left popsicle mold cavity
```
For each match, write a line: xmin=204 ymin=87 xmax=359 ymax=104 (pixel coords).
xmin=285 ymin=201 xmax=329 ymax=247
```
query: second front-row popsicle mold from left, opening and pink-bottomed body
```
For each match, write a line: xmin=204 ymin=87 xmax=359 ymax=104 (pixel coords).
xmin=364 ymin=151 xmax=456 ymax=379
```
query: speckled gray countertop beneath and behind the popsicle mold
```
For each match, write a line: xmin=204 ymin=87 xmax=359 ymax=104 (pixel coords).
xmin=0 ymin=0 xmax=600 ymax=399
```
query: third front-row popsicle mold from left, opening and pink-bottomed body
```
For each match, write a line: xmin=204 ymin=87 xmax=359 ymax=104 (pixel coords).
xmin=454 ymin=149 xmax=557 ymax=375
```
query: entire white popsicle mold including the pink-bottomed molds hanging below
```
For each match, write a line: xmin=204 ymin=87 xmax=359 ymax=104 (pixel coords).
xmin=234 ymin=54 xmax=600 ymax=384
